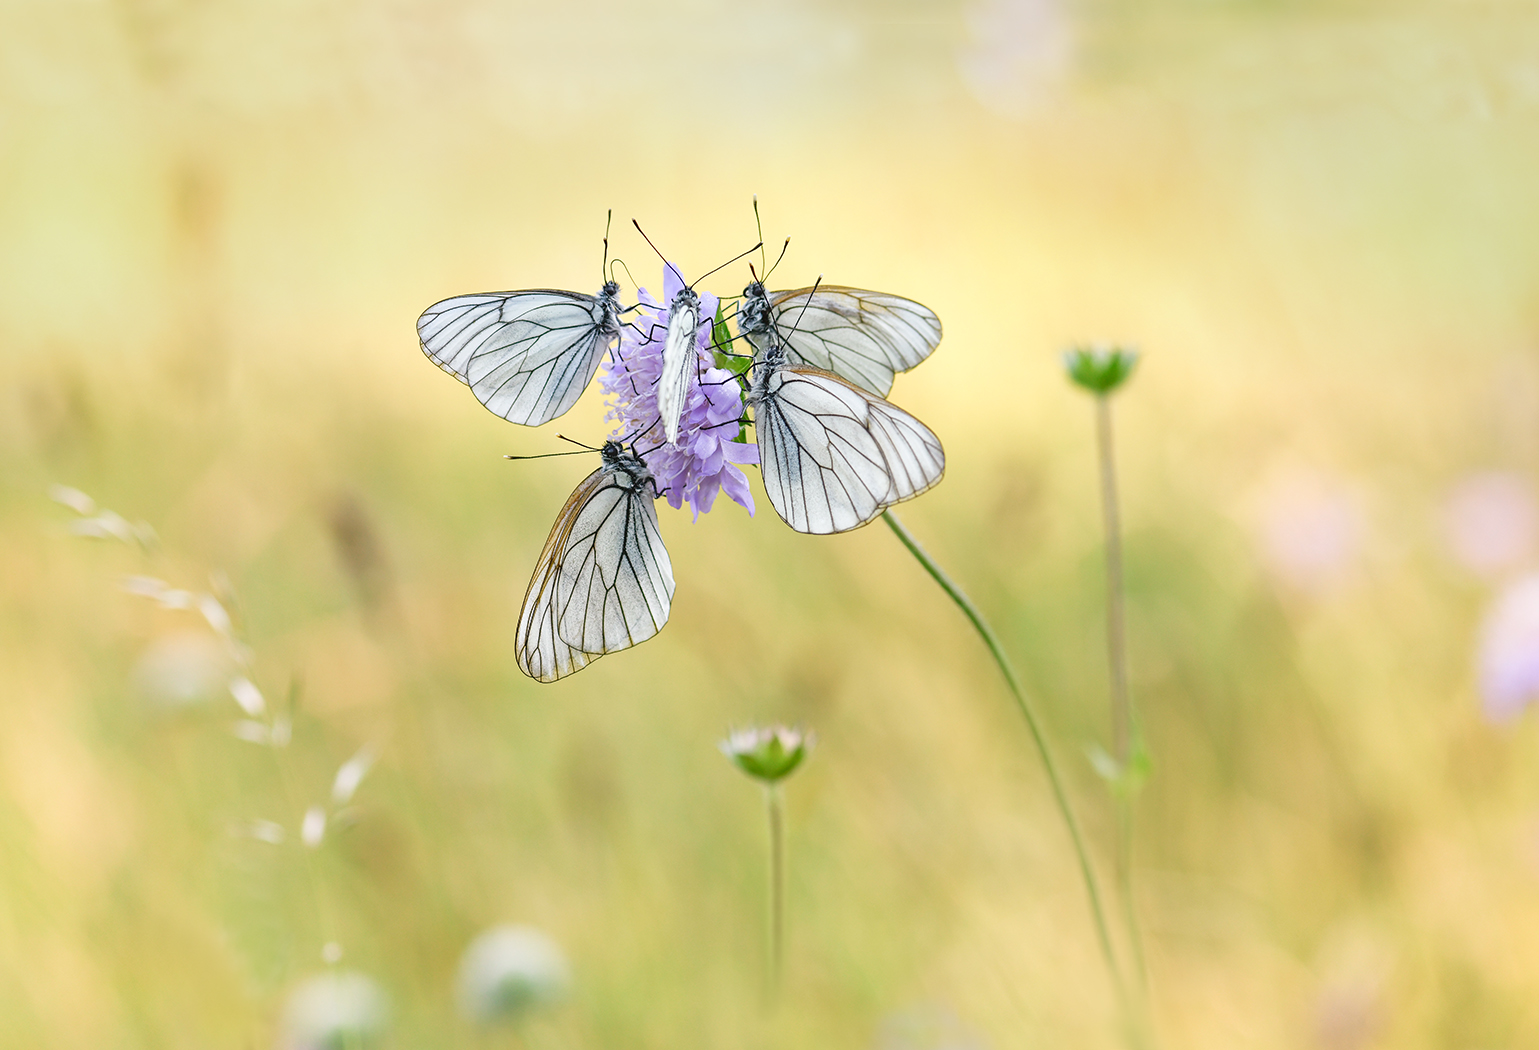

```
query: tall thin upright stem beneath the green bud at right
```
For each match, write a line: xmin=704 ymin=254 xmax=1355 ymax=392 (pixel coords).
xmin=1096 ymin=394 xmax=1148 ymax=988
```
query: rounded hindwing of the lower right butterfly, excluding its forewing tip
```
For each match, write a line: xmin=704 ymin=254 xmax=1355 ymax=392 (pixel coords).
xmin=754 ymin=366 xmax=898 ymax=534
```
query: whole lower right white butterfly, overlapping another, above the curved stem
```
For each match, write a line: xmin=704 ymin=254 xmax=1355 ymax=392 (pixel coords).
xmin=746 ymin=337 xmax=946 ymax=534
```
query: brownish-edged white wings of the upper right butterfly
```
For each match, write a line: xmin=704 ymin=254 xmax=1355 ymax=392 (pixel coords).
xmin=770 ymin=285 xmax=940 ymax=397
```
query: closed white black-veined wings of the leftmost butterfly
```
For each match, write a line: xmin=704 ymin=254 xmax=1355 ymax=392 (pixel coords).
xmin=417 ymin=288 xmax=619 ymax=426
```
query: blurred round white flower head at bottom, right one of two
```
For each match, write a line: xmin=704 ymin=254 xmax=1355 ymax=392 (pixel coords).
xmin=460 ymin=925 xmax=571 ymax=1022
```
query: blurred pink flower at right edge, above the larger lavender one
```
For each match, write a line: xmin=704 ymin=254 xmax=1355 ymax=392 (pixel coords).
xmin=1444 ymin=471 xmax=1539 ymax=577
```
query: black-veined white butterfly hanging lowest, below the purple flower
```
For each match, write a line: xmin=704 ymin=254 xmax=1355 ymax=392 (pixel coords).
xmin=516 ymin=442 xmax=674 ymax=682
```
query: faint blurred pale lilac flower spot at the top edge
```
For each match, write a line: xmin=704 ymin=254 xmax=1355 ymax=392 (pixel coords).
xmin=957 ymin=0 xmax=1074 ymax=117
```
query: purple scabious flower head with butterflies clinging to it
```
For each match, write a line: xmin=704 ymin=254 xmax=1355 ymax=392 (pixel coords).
xmin=599 ymin=266 xmax=759 ymax=519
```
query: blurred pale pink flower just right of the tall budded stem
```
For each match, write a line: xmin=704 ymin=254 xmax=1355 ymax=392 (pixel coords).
xmin=1257 ymin=471 xmax=1365 ymax=593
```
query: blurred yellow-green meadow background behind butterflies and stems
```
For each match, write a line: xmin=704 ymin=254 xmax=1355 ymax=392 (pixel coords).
xmin=0 ymin=0 xmax=1539 ymax=1050
